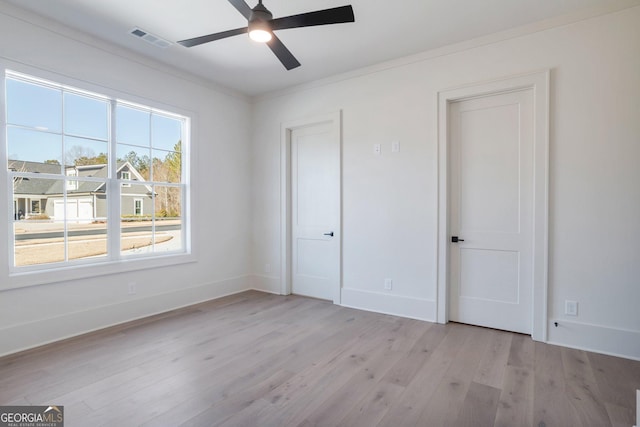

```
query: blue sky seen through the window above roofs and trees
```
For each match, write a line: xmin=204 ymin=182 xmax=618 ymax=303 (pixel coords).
xmin=6 ymin=78 xmax=183 ymax=164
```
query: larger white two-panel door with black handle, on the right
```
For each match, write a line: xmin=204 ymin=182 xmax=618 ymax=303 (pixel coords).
xmin=449 ymin=90 xmax=534 ymax=334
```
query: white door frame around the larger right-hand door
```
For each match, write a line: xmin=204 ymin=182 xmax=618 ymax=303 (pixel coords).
xmin=436 ymin=70 xmax=550 ymax=341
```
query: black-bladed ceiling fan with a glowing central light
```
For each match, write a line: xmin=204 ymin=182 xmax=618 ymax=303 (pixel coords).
xmin=178 ymin=0 xmax=355 ymax=70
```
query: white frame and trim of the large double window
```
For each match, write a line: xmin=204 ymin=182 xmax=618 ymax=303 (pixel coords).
xmin=0 ymin=69 xmax=197 ymax=290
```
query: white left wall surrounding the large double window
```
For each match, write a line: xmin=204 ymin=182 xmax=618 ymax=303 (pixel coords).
xmin=0 ymin=3 xmax=251 ymax=355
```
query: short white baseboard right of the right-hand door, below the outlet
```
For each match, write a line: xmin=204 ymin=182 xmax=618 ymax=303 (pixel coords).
xmin=547 ymin=319 xmax=640 ymax=360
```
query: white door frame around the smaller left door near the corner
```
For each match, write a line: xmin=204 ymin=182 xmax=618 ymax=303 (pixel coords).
xmin=280 ymin=111 xmax=342 ymax=304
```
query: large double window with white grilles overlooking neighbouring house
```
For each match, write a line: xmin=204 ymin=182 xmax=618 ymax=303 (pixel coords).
xmin=5 ymin=71 xmax=189 ymax=272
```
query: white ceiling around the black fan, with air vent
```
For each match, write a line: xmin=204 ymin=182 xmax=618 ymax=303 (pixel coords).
xmin=0 ymin=0 xmax=630 ymax=95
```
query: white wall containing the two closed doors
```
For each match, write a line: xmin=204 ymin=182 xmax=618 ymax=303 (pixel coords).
xmin=252 ymin=7 xmax=640 ymax=359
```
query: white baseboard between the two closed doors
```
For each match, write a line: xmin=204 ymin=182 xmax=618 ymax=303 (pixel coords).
xmin=341 ymin=288 xmax=436 ymax=322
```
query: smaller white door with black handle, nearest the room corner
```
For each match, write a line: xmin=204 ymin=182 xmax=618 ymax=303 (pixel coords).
xmin=291 ymin=123 xmax=340 ymax=300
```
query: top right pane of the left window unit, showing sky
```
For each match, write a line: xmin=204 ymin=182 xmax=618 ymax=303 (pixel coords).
xmin=64 ymin=93 xmax=108 ymax=140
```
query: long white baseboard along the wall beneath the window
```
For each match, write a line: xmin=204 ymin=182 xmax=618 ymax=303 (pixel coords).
xmin=0 ymin=276 xmax=251 ymax=356
